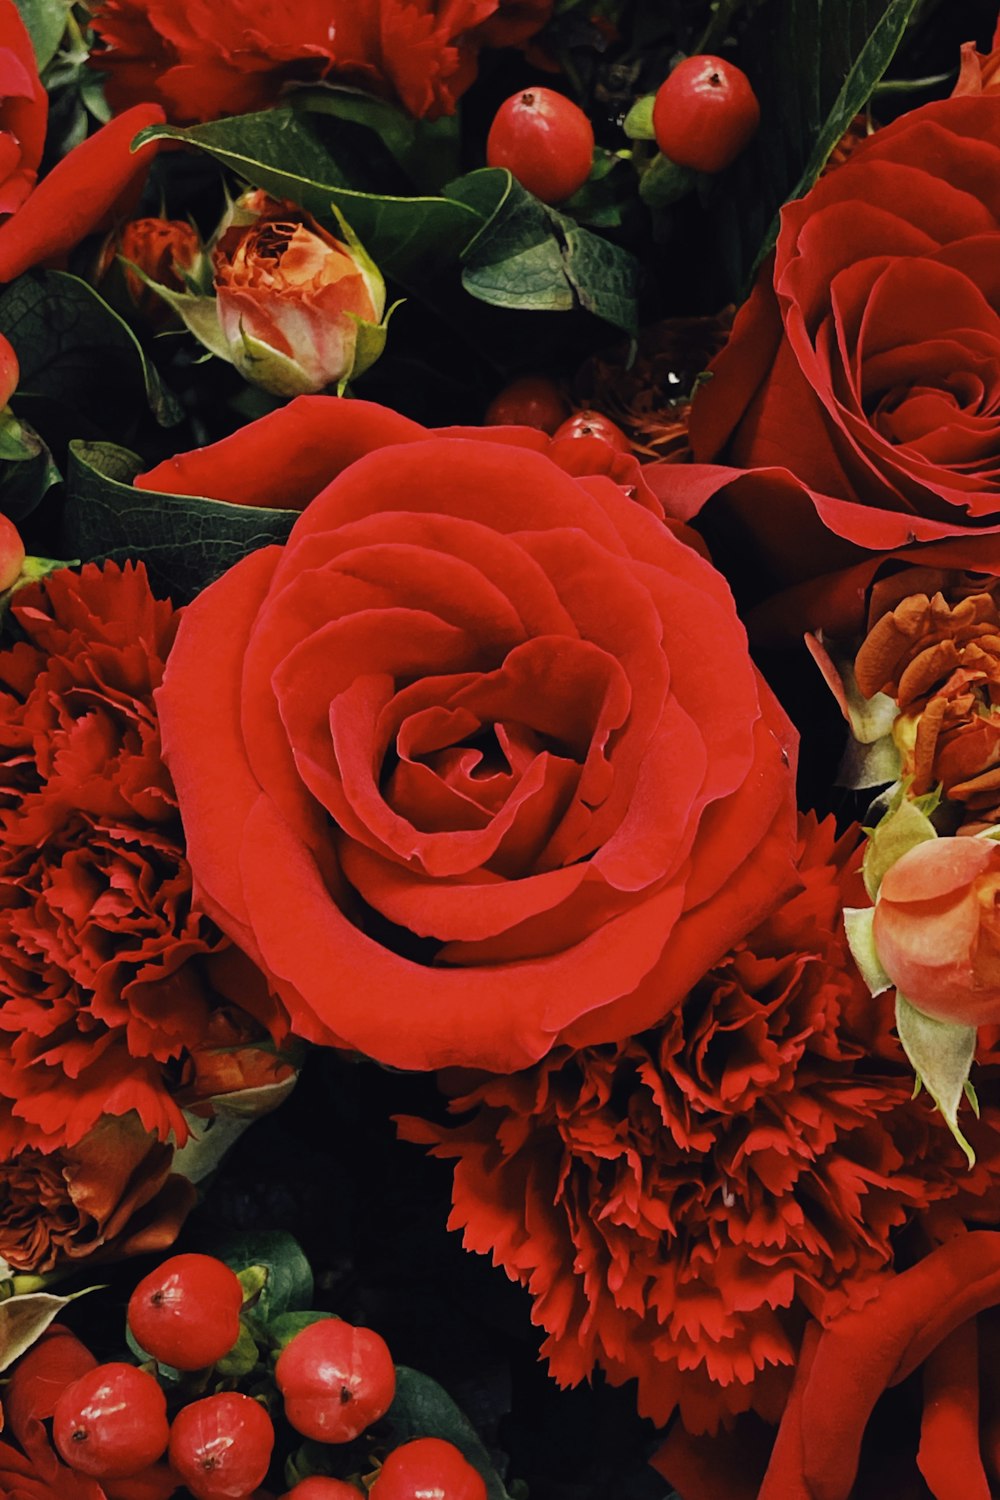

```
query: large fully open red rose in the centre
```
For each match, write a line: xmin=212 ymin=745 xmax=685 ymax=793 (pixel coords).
xmin=157 ymin=398 xmax=795 ymax=1070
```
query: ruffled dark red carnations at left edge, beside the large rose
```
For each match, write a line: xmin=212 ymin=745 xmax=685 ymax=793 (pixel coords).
xmin=0 ymin=564 xmax=284 ymax=1157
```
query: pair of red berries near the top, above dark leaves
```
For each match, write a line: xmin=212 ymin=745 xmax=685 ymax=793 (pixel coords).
xmin=486 ymin=54 xmax=760 ymax=204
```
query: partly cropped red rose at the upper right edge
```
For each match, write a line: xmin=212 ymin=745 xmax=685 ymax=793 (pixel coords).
xmin=668 ymin=93 xmax=1000 ymax=581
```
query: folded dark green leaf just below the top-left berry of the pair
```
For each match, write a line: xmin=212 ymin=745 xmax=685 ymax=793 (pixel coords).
xmin=445 ymin=167 xmax=639 ymax=333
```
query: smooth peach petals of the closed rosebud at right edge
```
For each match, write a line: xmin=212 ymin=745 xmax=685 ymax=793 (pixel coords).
xmin=873 ymin=837 xmax=1000 ymax=1026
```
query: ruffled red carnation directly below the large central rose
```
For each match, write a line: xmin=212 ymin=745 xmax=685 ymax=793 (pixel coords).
xmin=402 ymin=819 xmax=1000 ymax=1431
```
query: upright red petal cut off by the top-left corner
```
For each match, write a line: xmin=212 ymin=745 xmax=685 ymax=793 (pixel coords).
xmin=0 ymin=0 xmax=48 ymax=213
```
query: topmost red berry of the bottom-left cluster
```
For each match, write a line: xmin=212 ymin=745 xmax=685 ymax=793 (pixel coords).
xmin=127 ymin=1256 xmax=243 ymax=1370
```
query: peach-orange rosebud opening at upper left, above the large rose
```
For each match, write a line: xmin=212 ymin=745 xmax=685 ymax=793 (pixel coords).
xmin=213 ymin=191 xmax=385 ymax=396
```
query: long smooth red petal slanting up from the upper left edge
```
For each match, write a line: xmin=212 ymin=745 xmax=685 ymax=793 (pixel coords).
xmin=0 ymin=105 xmax=163 ymax=282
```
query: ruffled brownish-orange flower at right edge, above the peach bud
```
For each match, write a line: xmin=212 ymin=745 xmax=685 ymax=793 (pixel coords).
xmin=855 ymin=575 xmax=1000 ymax=831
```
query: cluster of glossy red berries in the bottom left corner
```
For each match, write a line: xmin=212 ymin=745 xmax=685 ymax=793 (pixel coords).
xmin=52 ymin=1254 xmax=486 ymax=1500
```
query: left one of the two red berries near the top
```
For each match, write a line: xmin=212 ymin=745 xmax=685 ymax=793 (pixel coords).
xmin=486 ymin=89 xmax=594 ymax=203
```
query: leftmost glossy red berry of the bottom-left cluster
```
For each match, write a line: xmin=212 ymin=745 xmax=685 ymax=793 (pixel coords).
xmin=52 ymin=1364 xmax=169 ymax=1479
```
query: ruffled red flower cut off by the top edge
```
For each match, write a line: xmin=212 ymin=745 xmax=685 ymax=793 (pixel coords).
xmin=85 ymin=0 xmax=552 ymax=120
